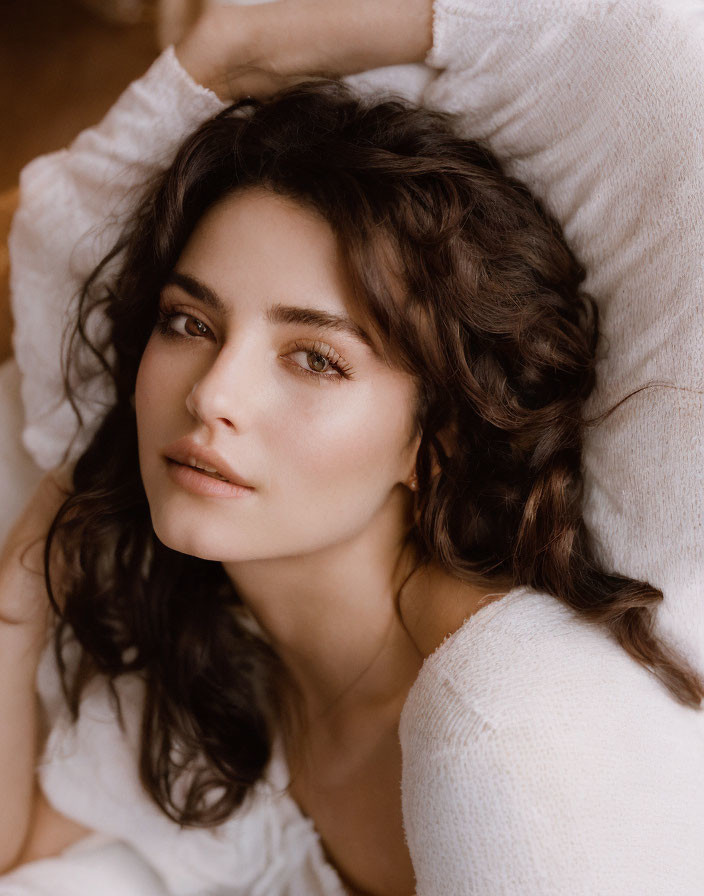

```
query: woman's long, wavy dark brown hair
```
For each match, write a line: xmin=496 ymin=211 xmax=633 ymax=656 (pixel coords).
xmin=46 ymin=78 xmax=704 ymax=825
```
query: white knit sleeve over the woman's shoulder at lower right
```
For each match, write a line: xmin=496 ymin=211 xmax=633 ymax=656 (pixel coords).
xmin=399 ymin=589 xmax=704 ymax=896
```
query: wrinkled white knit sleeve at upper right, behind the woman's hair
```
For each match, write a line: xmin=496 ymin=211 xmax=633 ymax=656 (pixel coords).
xmin=423 ymin=0 xmax=704 ymax=671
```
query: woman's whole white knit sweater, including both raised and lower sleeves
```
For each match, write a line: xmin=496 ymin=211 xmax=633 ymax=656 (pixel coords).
xmin=5 ymin=0 xmax=704 ymax=896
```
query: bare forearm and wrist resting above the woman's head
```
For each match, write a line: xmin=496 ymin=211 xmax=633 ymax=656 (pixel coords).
xmin=175 ymin=0 xmax=432 ymax=102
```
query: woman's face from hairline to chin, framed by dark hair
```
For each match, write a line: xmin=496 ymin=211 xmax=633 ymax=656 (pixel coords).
xmin=135 ymin=188 xmax=419 ymax=562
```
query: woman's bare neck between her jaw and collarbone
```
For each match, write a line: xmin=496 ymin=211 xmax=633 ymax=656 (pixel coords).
xmin=224 ymin=494 xmax=418 ymax=717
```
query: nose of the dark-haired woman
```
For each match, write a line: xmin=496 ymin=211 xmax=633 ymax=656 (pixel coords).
xmin=186 ymin=349 xmax=256 ymax=429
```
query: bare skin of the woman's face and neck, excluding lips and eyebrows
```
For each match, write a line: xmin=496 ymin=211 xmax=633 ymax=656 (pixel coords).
xmin=135 ymin=189 xmax=426 ymax=714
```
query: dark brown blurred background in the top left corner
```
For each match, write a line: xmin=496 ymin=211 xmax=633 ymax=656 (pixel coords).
xmin=0 ymin=0 xmax=158 ymax=192
